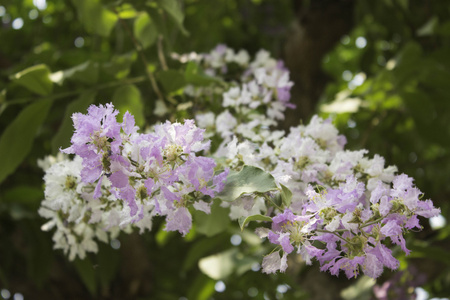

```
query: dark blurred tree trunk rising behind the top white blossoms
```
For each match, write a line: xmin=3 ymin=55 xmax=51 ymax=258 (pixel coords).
xmin=283 ymin=0 xmax=355 ymax=129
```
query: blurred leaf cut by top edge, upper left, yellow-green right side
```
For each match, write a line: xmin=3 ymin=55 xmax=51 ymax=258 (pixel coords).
xmin=72 ymin=0 xmax=118 ymax=37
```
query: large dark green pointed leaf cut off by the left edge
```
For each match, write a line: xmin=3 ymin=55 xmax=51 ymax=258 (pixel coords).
xmin=0 ymin=99 xmax=53 ymax=183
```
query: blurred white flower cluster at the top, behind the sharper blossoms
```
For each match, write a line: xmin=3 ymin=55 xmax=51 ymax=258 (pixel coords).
xmin=180 ymin=45 xmax=295 ymax=146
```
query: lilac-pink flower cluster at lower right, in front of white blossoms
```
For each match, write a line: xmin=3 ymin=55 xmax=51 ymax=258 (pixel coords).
xmin=258 ymin=174 xmax=440 ymax=278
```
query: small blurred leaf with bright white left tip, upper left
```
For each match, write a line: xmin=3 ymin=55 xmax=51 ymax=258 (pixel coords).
xmin=50 ymin=61 xmax=99 ymax=85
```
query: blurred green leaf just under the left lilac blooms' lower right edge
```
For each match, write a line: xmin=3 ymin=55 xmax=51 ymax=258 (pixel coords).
xmin=193 ymin=201 xmax=231 ymax=237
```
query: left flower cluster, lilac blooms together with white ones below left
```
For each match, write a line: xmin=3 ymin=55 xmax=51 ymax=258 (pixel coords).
xmin=40 ymin=104 xmax=228 ymax=259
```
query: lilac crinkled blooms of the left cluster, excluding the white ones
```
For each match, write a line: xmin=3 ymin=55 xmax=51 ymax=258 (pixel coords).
xmin=56 ymin=104 xmax=228 ymax=235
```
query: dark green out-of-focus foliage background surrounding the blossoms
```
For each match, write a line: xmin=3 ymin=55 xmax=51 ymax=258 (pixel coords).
xmin=0 ymin=0 xmax=450 ymax=300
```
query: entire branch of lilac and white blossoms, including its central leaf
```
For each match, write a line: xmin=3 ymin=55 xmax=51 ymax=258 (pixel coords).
xmin=39 ymin=45 xmax=440 ymax=278
